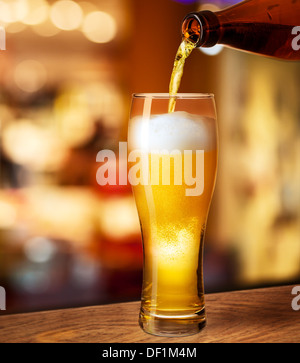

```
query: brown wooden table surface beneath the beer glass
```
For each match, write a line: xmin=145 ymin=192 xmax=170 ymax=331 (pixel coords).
xmin=0 ymin=286 xmax=300 ymax=343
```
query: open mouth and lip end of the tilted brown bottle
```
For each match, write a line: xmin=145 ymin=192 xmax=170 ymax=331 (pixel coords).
xmin=182 ymin=10 xmax=220 ymax=47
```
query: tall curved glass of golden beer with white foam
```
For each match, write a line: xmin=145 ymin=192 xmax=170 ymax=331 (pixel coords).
xmin=128 ymin=94 xmax=218 ymax=336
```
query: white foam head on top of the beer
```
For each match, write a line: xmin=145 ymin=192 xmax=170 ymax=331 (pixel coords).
xmin=128 ymin=111 xmax=216 ymax=152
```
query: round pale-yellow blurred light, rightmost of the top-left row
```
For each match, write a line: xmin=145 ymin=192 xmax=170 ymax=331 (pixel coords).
xmin=82 ymin=11 xmax=117 ymax=43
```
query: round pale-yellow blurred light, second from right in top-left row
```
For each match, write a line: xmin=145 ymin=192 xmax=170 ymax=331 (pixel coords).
xmin=50 ymin=0 xmax=83 ymax=30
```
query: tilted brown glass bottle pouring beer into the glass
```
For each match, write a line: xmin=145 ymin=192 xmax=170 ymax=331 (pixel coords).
xmin=182 ymin=0 xmax=300 ymax=60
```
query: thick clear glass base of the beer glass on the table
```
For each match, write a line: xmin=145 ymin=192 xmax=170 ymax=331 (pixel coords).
xmin=139 ymin=308 xmax=206 ymax=337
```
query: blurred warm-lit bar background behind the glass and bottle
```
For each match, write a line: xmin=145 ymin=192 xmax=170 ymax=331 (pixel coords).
xmin=0 ymin=0 xmax=300 ymax=313
